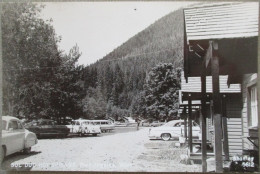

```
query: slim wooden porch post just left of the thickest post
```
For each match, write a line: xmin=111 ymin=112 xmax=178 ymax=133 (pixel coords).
xmin=200 ymin=69 xmax=207 ymax=172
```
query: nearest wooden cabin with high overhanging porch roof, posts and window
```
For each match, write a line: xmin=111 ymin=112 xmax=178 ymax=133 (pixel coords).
xmin=183 ymin=2 xmax=259 ymax=172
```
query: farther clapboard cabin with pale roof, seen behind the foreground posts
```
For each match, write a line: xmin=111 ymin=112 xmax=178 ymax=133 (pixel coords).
xmin=179 ymin=73 xmax=243 ymax=156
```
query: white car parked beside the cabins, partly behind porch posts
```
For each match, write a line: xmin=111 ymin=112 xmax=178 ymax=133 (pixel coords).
xmin=149 ymin=120 xmax=200 ymax=141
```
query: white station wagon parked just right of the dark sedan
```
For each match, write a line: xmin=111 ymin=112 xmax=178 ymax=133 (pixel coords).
xmin=67 ymin=119 xmax=101 ymax=136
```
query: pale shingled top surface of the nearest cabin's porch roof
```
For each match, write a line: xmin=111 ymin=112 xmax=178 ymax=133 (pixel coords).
xmin=184 ymin=2 xmax=259 ymax=44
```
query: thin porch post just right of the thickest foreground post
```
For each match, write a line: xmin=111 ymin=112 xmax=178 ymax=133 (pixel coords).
xmin=221 ymin=95 xmax=229 ymax=160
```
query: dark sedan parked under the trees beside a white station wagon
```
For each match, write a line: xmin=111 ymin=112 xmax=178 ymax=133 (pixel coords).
xmin=25 ymin=119 xmax=70 ymax=138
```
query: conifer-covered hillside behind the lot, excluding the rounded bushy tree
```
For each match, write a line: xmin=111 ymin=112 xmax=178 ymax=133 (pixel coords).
xmin=82 ymin=9 xmax=184 ymax=121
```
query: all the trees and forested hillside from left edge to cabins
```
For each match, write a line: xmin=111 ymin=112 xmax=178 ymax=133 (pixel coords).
xmin=1 ymin=3 xmax=183 ymax=123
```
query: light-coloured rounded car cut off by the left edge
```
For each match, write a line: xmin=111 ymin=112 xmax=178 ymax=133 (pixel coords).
xmin=1 ymin=116 xmax=38 ymax=162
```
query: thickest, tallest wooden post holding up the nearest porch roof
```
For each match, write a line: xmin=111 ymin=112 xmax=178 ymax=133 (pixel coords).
xmin=211 ymin=42 xmax=223 ymax=173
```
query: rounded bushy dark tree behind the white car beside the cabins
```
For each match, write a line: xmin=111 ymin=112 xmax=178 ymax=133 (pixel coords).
xmin=144 ymin=63 xmax=180 ymax=119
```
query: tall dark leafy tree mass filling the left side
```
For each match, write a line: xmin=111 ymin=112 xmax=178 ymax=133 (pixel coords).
xmin=1 ymin=3 xmax=83 ymax=122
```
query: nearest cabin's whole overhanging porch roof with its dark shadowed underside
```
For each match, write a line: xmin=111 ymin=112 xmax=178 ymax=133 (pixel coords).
xmin=184 ymin=2 xmax=259 ymax=79
